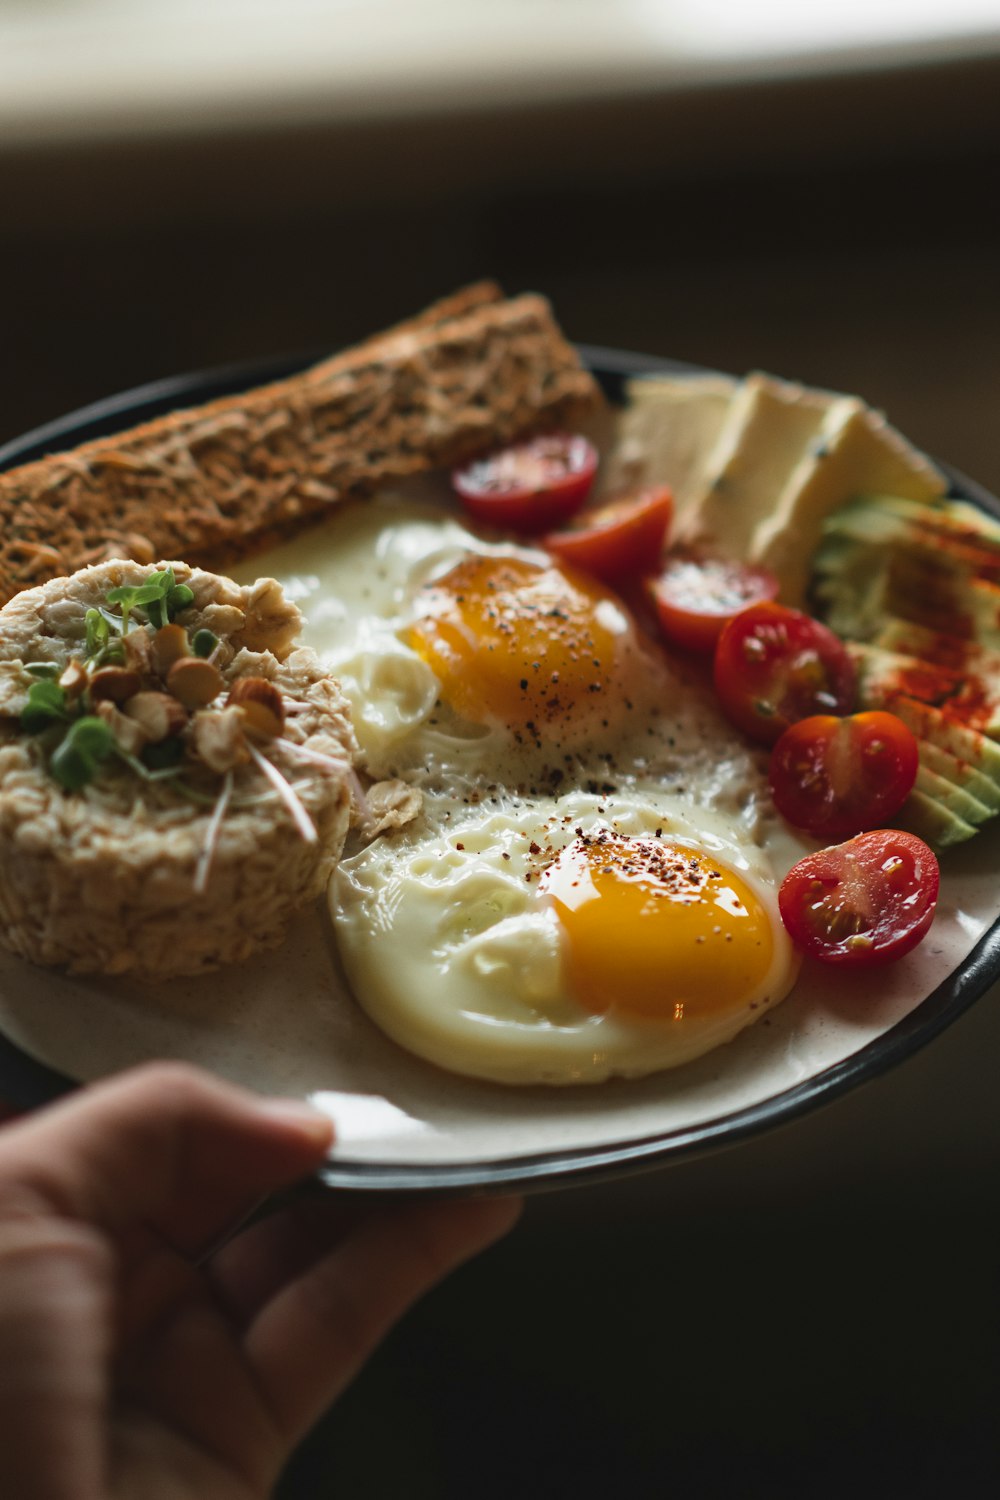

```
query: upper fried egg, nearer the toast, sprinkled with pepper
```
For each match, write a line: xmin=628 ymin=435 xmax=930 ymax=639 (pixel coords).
xmin=237 ymin=495 xmax=756 ymax=818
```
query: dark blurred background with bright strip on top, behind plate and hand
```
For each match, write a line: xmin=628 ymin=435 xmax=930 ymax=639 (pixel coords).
xmin=0 ymin=0 xmax=1000 ymax=1500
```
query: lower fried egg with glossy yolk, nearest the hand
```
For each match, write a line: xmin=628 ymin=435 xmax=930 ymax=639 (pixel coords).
xmin=330 ymin=791 xmax=798 ymax=1085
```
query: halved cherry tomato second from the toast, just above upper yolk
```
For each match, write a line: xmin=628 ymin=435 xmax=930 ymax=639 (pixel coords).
xmin=544 ymin=485 xmax=673 ymax=585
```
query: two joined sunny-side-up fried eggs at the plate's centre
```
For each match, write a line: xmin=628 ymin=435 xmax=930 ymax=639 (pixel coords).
xmin=238 ymin=495 xmax=796 ymax=1083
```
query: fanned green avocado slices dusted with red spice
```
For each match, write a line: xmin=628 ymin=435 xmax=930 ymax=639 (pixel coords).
xmin=811 ymin=495 xmax=1000 ymax=849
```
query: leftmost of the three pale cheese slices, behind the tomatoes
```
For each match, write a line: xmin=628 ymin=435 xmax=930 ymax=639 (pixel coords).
xmin=601 ymin=375 xmax=738 ymax=516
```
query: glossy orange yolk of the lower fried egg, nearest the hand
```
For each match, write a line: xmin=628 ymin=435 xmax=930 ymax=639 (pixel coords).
xmin=538 ymin=833 xmax=774 ymax=1022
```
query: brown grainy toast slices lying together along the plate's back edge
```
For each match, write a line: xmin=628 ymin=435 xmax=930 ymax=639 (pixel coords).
xmin=0 ymin=282 xmax=601 ymax=603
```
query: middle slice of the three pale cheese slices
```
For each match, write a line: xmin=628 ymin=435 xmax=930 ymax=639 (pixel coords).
xmin=675 ymin=374 xmax=844 ymax=558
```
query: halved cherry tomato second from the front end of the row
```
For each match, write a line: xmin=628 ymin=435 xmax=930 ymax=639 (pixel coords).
xmin=771 ymin=710 xmax=919 ymax=839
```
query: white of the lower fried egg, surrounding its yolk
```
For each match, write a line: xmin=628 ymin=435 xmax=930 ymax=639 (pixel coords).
xmin=330 ymin=791 xmax=798 ymax=1085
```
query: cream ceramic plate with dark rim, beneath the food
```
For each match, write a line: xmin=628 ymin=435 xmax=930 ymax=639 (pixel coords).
xmin=0 ymin=350 xmax=1000 ymax=1191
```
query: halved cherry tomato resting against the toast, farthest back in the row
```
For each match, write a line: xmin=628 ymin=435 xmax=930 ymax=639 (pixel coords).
xmin=451 ymin=432 xmax=597 ymax=536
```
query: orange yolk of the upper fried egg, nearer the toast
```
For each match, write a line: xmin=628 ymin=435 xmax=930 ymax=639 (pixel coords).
xmin=406 ymin=555 xmax=633 ymax=743
